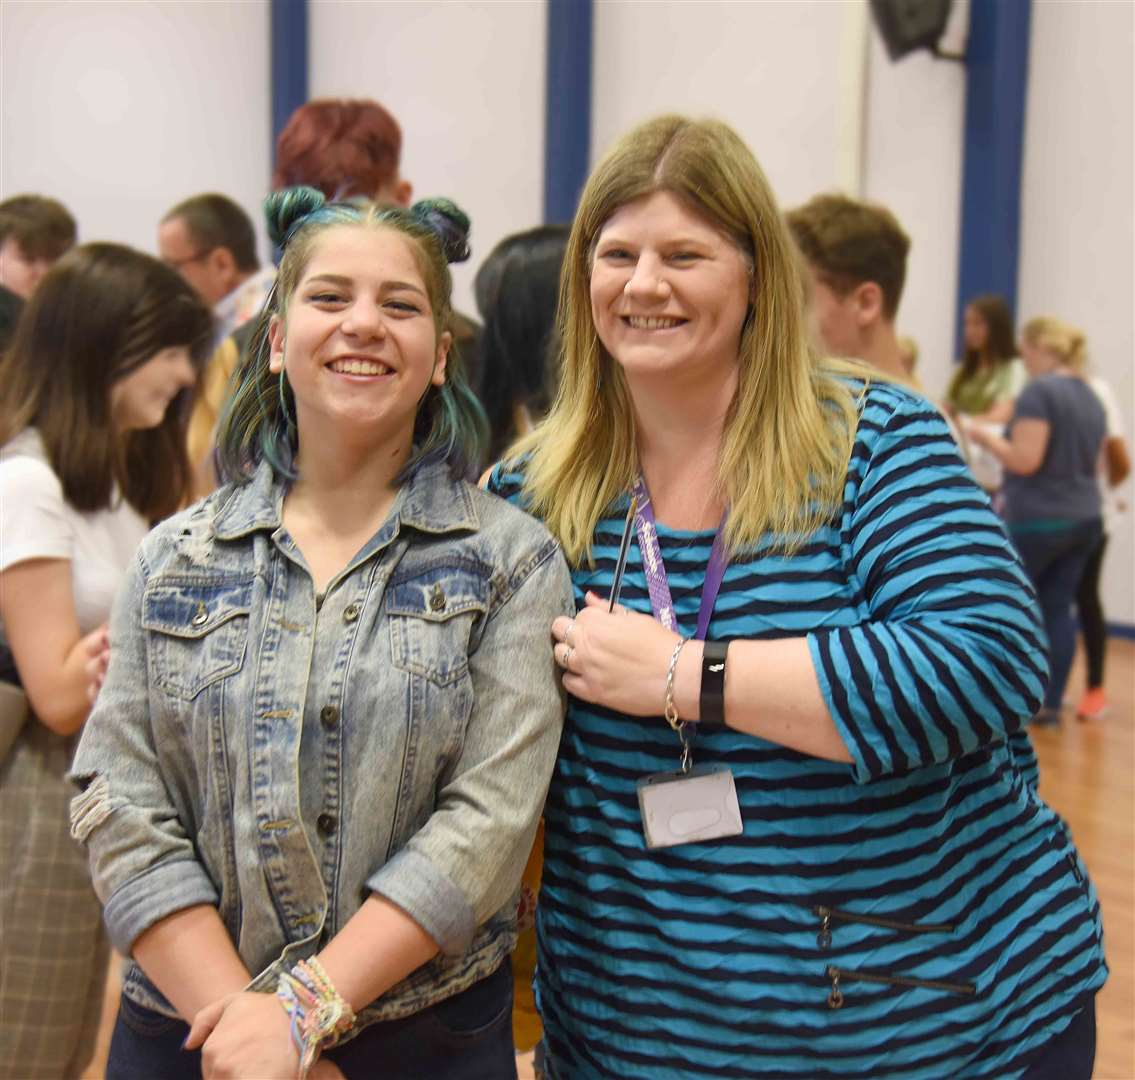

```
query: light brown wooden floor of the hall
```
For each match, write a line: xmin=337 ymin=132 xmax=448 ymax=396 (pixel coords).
xmin=83 ymin=640 xmax=1135 ymax=1080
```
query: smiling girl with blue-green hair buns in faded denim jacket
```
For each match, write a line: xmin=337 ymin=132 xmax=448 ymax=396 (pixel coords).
xmin=72 ymin=188 xmax=572 ymax=1080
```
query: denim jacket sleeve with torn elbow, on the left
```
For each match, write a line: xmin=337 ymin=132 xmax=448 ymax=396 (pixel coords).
xmin=68 ymin=548 xmax=218 ymax=953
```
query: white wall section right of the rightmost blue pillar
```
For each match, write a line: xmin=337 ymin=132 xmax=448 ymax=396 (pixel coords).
xmin=1018 ymin=0 xmax=1135 ymax=624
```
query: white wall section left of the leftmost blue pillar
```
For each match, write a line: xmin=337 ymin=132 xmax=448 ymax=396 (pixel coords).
xmin=0 ymin=0 xmax=270 ymax=262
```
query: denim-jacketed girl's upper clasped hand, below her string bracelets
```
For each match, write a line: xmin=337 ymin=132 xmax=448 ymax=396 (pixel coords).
xmin=185 ymin=990 xmax=300 ymax=1080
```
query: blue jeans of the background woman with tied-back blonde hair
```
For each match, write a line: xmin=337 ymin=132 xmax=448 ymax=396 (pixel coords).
xmin=1010 ymin=517 xmax=1103 ymax=710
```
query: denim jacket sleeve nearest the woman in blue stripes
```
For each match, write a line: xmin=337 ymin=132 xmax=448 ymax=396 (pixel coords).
xmin=367 ymin=534 xmax=575 ymax=955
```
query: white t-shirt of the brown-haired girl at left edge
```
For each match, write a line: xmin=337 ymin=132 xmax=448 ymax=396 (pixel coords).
xmin=0 ymin=428 xmax=150 ymax=643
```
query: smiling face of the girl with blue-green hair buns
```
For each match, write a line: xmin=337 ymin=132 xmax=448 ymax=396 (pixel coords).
xmin=269 ymin=225 xmax=451 ymax=453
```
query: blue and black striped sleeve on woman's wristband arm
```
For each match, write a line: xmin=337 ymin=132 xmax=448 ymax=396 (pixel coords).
xmin=808 ymin=388 xmax=1048 ymax=783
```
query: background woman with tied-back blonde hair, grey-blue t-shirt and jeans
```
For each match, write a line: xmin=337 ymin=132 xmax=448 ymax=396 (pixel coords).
xmin=969 ymin=317 xmax=1107 ymax=725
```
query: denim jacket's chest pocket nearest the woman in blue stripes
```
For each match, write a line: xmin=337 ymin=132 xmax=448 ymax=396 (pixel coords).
xmin=386 ymin=566 xmax=488 ymax=686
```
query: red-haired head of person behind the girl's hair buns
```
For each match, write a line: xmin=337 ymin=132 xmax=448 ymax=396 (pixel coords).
xmin=272 ymin=98 xmax=413 ymax=206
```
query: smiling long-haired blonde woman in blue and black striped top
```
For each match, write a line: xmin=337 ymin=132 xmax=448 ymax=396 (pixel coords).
xmin=489 ymin=117 xmax=1105 ymax=1080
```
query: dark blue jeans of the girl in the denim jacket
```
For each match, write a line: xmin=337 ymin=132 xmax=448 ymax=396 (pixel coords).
xmin=107 ymin=964 xmax=516 ymax=1080
